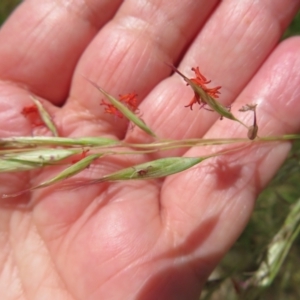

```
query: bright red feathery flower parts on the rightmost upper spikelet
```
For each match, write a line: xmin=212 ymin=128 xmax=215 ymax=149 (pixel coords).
xmin=185 ymin=67 xmax=221 ymax=110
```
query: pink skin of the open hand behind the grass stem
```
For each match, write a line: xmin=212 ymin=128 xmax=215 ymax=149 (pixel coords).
xmin=0 ymin=0 xmax=300 ymax=300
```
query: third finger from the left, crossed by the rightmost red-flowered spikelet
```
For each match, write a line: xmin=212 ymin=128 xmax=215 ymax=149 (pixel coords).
xmin=128 ymin=0 xmax=299 ymax=149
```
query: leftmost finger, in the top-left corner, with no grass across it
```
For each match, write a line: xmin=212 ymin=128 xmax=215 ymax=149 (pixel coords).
xmin=0 ymin=0 xmax=122 ymax=103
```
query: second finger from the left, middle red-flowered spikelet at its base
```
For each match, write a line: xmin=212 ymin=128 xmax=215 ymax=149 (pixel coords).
xmin=66 ymin=0 xmax=217 ymax=137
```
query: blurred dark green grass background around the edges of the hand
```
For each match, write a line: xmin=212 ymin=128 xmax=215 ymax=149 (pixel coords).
xmin=0 ymin=0 xmax=300 ymax=300
